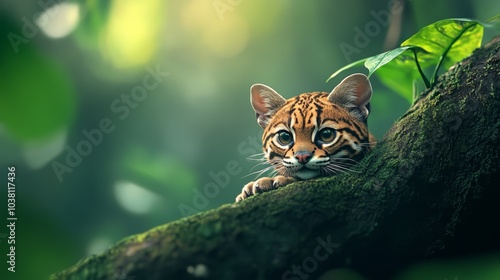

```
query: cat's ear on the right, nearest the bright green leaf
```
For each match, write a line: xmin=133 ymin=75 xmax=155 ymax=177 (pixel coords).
xmin=328 ymin=73 xmax=372 ymax=120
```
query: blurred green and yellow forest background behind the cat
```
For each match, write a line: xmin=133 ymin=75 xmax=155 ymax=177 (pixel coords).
xmin=0 ymin=0 xmax=500 ymax=279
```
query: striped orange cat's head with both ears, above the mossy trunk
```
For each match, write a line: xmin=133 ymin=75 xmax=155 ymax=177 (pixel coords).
xmin=250 ymin=74 xmax=372 ymax=180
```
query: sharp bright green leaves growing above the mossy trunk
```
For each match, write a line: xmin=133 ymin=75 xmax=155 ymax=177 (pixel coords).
xmin=330 ymin=18 xmax=486 ymax=102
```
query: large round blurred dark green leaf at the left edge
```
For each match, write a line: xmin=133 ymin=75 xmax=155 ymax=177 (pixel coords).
xmin=0 ymin=48 xmax=75 ymax=141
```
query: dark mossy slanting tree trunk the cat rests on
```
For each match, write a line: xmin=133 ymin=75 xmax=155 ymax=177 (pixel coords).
xmin=52 ymin=37 xmax=500 ymax=280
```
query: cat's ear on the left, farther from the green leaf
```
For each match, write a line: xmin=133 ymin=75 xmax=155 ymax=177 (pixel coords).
xmin=250 ymin=84 xmax=286 ymax=128
